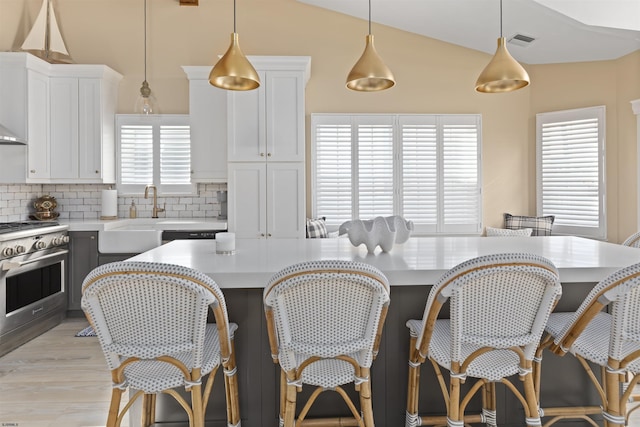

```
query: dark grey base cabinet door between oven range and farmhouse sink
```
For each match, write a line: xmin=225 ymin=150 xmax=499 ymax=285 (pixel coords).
xmin=67 ymin=231 xmax=98 ymax=310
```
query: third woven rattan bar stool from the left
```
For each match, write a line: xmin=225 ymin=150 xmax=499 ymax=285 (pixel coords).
xmin=406 ymin=253 xmax=562 ymax=427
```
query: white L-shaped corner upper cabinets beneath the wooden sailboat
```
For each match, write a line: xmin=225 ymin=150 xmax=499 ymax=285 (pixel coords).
xmin=0 ymin=52 xmax=122 ymax=184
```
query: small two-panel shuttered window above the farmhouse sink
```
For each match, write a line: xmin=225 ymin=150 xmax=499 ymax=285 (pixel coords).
xmin=116 ymin=114 xmax=195 ymax=194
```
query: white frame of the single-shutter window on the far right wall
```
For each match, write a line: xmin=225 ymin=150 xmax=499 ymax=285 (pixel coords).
xmin=536 ymin=105 xmax=607 ymax=240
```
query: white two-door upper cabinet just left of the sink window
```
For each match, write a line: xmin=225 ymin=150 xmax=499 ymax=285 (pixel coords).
xmin=45 ymin=64 xmax=122 ymax=184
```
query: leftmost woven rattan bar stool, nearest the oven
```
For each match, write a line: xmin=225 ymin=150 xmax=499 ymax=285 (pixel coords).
xmin=82 ymin=262 xmax=240 ymax=427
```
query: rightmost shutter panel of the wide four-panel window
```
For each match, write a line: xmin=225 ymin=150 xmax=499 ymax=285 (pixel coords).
xmin=439 ymin=116 xmax=481 ymax=232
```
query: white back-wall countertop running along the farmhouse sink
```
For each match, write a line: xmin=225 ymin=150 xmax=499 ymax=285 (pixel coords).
xmin=58 ymin=218 xmax=227 ymax=231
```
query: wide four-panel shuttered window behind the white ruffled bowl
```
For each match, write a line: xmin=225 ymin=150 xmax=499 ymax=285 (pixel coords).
xmin=311 ymin=114 xmax=482 ymax=234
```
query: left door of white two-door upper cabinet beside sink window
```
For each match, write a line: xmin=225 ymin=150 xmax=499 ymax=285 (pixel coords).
xmin=49 ymin=77 xmax=78 ymax=179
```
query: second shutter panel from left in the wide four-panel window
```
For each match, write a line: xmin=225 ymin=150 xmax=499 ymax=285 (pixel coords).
xmin=355 ymin=116 xmax=394 ymax=219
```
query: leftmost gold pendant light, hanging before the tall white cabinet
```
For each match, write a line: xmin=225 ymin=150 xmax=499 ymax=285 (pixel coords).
xmin=209 ymin=0 xmax=260 ymax=90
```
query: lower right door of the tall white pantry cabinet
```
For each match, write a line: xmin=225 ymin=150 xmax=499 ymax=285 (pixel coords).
xmin=267 ymin=162 xmax=305 ymax=238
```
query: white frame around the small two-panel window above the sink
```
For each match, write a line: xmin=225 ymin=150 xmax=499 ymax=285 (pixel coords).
xmin=115 ymin=114 xmax=197 ymax=196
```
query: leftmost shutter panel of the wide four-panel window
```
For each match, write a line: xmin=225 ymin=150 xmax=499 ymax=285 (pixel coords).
xmin=312 ymin=117 xmax=353 ymax=225
